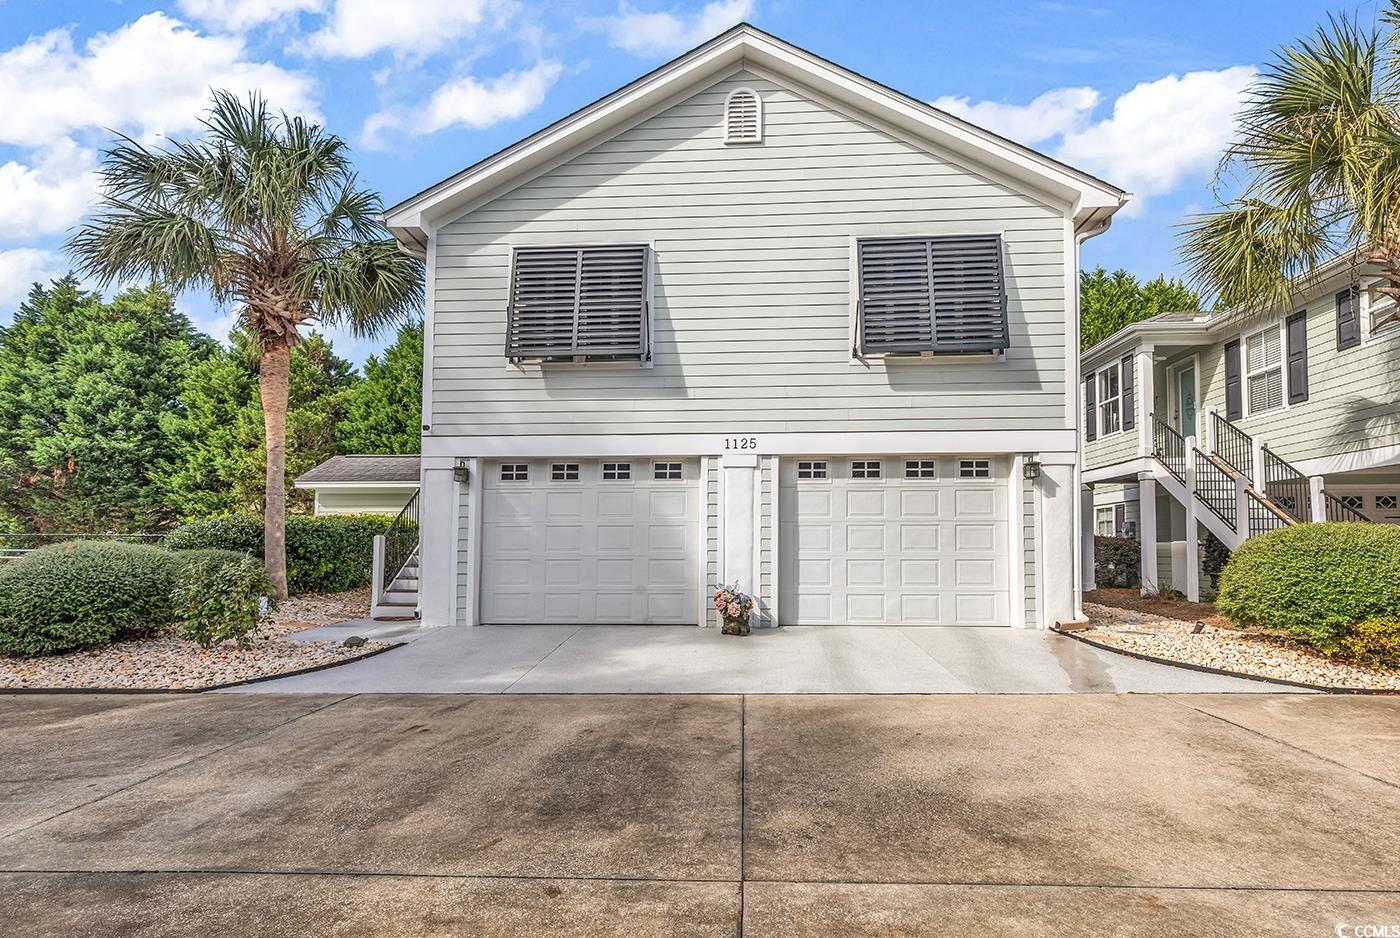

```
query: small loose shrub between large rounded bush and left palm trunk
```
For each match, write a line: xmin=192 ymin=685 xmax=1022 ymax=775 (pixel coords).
xmin=171 ymin=549 xmax=272 ymax=648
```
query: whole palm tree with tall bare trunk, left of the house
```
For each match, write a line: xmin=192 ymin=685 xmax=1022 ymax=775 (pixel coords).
xmin=69 ymin=91 xmax=423 ymax=598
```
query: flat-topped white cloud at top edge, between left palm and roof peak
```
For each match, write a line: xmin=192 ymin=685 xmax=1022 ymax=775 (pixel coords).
xmin=302 ymin=0 xmax=510 ymax=59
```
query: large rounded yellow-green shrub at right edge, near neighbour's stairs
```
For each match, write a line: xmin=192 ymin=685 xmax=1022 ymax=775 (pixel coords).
xmin=1217 ymin=522 xmax=1400 ymax=647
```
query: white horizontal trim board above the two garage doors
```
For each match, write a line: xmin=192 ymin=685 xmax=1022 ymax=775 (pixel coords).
xmin=423 ymin=430 xmax=1078 ymax=469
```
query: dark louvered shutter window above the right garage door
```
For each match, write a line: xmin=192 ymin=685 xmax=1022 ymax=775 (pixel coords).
xmin=857 ymin=235 xmax=1011 ymax=356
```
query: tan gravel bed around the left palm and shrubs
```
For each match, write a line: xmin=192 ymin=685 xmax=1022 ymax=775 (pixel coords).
xmin=0 ymin=589 xmax=392 ymax=690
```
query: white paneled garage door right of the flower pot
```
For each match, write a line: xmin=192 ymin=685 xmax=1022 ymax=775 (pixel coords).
xmin=778 ymin=456 xmax=1011 ymax=626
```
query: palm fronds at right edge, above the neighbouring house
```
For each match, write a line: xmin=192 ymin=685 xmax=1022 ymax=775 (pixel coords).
xmin=1182 ymin=0 xmax=1400 ymax=309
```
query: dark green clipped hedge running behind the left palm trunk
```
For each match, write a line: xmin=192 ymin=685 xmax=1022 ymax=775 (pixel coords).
xmin=165 ymin=515 xmax=393 ymax=594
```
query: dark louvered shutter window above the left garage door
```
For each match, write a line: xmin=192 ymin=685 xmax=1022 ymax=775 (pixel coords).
xmin=505 ymin=245 xmax=650 ymax=361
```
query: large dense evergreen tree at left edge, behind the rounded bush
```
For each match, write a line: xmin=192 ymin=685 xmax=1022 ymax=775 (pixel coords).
xmin=0 ymin=277 xmax=216 ymax=533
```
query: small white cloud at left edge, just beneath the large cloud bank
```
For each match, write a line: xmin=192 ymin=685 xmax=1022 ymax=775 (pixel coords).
xmin=0 ymin=139 xmax=98 ymax=241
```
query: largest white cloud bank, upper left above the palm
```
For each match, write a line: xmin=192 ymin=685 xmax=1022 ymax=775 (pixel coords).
xmin=0 ymin=13 xmax=315 ymax=147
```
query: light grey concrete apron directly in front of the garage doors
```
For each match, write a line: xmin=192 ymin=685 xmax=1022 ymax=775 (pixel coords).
xmin=221 ymin=620 xmax=1280 ymax=693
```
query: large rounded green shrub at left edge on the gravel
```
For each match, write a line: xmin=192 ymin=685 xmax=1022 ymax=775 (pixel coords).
xmin=0 ymin=540 xmax=178 ymax=655
